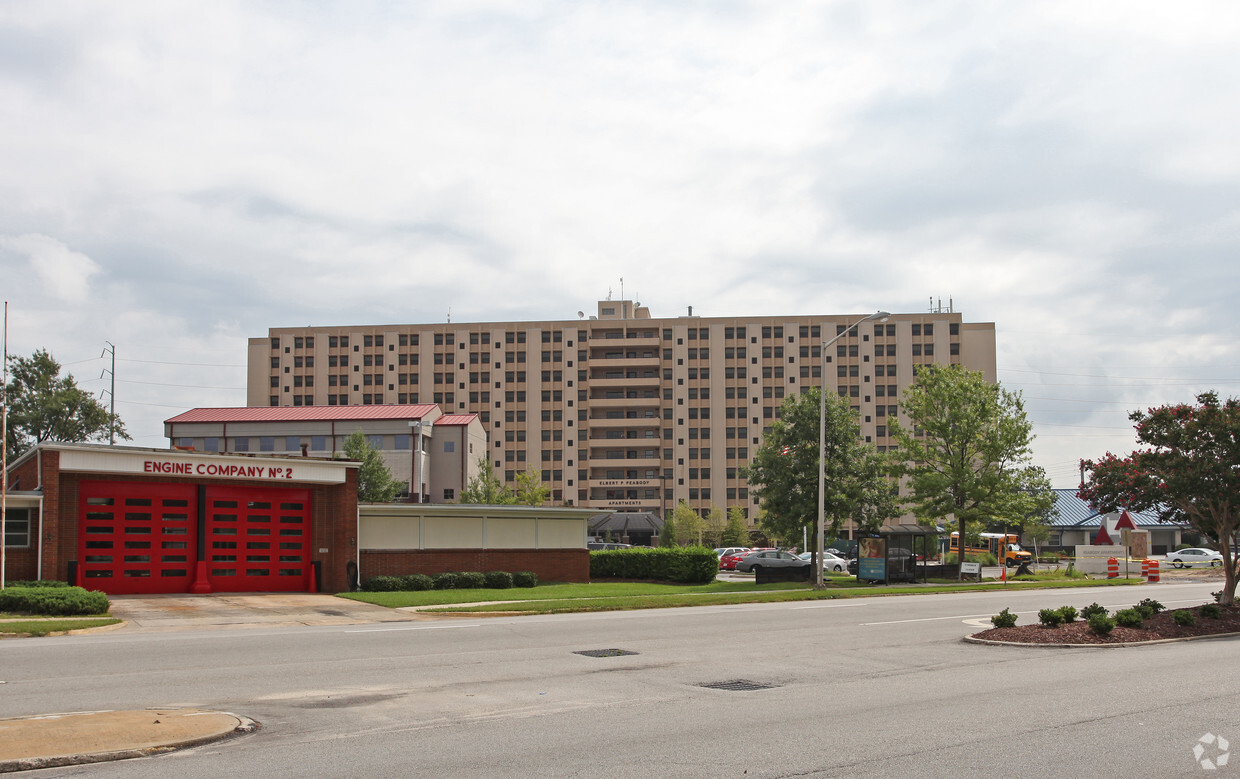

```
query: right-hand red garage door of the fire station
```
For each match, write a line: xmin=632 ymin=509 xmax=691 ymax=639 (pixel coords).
xmin=203 ymin=486 xmax=314 ymax=593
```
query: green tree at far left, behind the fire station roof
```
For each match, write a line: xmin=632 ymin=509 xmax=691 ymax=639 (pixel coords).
xmin=7 ymin=349 xmax=130 ymax=459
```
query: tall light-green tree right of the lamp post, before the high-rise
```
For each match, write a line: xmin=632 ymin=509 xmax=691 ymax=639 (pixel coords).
xmin=888 ymin=365 xmax=1053 ymax=578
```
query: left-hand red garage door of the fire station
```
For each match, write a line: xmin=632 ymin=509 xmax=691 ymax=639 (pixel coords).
xmin=78 ymin=481 xmax=197 ymax=594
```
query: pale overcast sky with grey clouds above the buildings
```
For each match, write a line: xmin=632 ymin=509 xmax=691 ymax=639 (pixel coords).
xmin=0 ymin=0 xmax=1240 ymax=486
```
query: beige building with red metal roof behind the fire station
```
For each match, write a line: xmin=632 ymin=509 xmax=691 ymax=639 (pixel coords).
xmin=164 ymin=403 xmax=486 ymax=502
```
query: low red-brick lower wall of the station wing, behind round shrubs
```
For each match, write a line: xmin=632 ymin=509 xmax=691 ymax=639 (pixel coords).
xmin=361 ymin=550 xmax=590 ymax=582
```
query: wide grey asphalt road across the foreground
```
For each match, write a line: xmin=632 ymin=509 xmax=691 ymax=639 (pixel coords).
xmin=0 ymin=583 xmax=1240 ymax=778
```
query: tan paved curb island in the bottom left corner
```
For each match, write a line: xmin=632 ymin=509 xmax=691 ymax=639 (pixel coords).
xmin=0 ymin=708 xmax=258 ymax=773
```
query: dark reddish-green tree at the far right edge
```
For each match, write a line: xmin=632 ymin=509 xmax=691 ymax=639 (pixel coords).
xmin=1078 ymin=392 xmax=1240 ymax=605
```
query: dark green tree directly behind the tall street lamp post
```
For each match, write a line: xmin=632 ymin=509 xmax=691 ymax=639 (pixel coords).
xmin=745 ymin=387 xmax=897 ymax=560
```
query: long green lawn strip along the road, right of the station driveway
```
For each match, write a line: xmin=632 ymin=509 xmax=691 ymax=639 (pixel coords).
xmin=340 ymin=579 xmax=1140 ymax=614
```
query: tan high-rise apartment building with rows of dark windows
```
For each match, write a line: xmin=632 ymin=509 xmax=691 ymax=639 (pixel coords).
xmin=247 ymin=300 xmax=996 ymax=516
